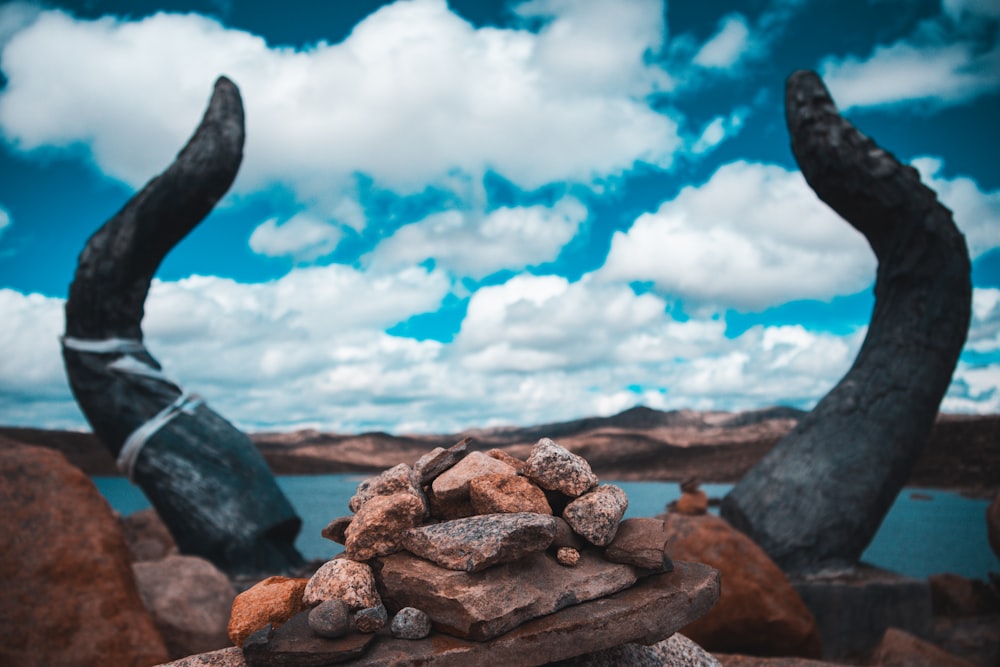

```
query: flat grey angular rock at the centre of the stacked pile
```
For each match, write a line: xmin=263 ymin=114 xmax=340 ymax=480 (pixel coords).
xmin=403 ymin=512 xmax=556 ymax=572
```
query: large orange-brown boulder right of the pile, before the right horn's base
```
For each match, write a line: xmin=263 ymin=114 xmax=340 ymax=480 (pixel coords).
xmin=662 ymin=514 xmax=821 ymax=658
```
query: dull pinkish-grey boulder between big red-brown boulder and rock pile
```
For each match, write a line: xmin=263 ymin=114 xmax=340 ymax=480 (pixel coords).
xmin=132 ymin=556 xmax=236 ymax=658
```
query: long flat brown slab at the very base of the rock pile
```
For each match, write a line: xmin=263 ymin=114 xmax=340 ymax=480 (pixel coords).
xmin=247 ymin=561 xmax=719 ymax=667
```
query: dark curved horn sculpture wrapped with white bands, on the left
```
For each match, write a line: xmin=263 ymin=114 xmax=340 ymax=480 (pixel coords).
xmin=62 ymin=77 xmax=303 ymax=574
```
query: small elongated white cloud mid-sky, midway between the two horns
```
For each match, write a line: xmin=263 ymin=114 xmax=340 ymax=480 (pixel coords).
xmin=372 ymin=197 xmax=587 ymax=278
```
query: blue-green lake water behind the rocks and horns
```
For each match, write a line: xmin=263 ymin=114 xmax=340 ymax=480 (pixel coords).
xmin=94 ymin=474 xmax=1000 ymax=579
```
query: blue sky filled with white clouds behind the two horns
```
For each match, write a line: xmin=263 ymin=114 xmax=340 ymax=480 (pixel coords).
xmin=0 ymin=0 xmax=1000 ymax=433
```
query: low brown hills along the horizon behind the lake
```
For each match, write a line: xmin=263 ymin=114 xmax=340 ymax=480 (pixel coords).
xmin=0 ymin=407 xmax=1000 ymax=496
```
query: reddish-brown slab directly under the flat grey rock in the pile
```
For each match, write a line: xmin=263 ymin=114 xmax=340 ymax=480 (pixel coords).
xmin=375 ymin=553 xmax=636 ymax=641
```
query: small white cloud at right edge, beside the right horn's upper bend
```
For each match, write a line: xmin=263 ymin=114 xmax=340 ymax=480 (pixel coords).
xmin=911 ymin=157 xmax=1000 ymax=259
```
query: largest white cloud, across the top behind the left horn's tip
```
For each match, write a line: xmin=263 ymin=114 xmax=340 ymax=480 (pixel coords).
xmin=0 ymin=0 xmax=680 ymax=214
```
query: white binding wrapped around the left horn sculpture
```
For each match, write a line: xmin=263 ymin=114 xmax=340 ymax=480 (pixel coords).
xmin=59 ymin=336 xmax=205 ymax=482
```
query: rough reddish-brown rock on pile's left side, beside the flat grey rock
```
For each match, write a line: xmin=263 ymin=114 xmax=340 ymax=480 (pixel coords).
xmin=344 ymin=493 xmax=425 ymax=561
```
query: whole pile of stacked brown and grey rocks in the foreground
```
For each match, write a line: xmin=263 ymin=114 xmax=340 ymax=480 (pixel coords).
xmin=230 ymin=439 xmax=719 ymax=667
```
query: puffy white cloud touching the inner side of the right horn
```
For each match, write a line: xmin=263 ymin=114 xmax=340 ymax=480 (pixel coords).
xmin=597 ymin=162 xmax=876 ymax=310
